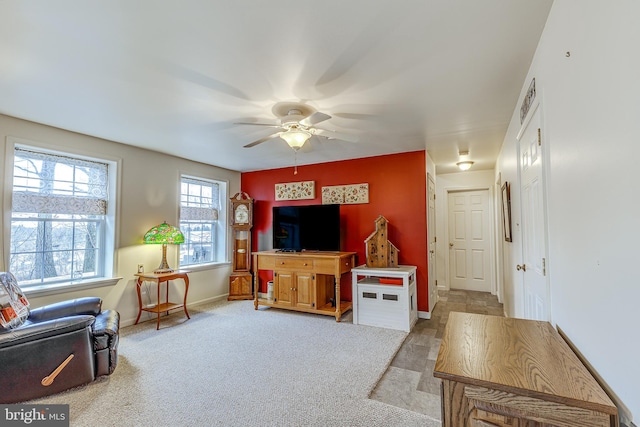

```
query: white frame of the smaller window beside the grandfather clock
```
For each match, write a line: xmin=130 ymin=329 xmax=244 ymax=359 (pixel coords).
xmin=178 ymin=173 xmax=229 ymax=270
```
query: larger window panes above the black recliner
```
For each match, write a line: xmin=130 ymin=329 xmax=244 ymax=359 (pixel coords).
xmin=9 ymin=145 xmax=114 ymax=290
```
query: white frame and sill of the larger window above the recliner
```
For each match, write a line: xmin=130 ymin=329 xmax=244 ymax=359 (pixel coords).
xmin=2 ymin=136 xmax=122 ymax=297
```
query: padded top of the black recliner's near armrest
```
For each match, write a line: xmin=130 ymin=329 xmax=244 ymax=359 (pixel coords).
xmin=0 ymin=314 xmax=95 ymax=348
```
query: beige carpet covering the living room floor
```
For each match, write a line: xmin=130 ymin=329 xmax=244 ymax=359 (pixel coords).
xmin=31 ymin=301 xmax=440 ymax=426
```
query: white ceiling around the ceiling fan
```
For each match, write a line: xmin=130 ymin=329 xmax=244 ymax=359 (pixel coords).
xmin=0 ymin=0 xmax=552 ymax=173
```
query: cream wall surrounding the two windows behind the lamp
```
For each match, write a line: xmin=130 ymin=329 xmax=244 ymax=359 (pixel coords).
xmin=0 ymin=115 xmax=240 ymax=325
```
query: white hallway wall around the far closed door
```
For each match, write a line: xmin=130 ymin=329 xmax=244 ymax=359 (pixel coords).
xmin=436 ymin=170 xmax=494 ymax=289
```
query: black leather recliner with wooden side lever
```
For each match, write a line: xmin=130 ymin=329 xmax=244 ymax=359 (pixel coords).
xmin=0 ymin=297 xmax=120 ymax=403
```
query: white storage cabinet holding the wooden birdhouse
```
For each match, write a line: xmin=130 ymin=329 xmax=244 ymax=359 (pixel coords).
xmin=351 ymin=265 xmax=418 ymax=332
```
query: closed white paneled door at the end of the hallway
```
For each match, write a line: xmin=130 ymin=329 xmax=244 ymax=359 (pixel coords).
xmin=448 ymin=190 xmax=491 ymax=292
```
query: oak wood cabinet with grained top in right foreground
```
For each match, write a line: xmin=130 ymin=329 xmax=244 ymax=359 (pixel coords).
xmin=433 ymin=312 xmax=619 ymax=427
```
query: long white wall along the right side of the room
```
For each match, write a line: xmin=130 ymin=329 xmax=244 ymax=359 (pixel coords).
xmin=496 ymin=0 xmax=640 ymax=418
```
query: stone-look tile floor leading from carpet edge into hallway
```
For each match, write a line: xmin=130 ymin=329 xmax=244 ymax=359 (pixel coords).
xmin=370 ymin=290 xmax=504 ymax=420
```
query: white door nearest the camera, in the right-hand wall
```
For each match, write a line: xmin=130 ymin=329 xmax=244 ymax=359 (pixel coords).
xmin=517 ymin=108 xmax=550 ymax=321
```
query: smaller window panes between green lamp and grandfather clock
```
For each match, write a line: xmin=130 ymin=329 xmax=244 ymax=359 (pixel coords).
xmin=180 ymin=176 xmax=226 ymax=266
